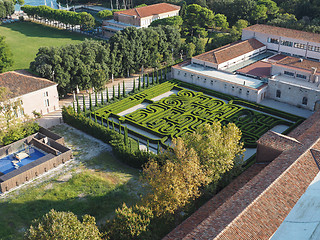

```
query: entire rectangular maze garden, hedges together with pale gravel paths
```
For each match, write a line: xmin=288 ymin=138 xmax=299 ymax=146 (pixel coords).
xmin=89 ymin=80 xmax=303 ymax=152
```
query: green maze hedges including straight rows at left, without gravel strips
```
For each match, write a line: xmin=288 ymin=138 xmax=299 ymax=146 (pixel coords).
xmin=95 ymin=81 xmax=300 ymax=147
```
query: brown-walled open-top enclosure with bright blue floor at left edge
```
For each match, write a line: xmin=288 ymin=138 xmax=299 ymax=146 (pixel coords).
xmin=0 ymin=128 xmax=72 ymax=192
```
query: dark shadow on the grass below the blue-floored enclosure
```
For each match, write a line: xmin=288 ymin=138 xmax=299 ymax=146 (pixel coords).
xmin=0 ymin=177 xmax=137 ymax=240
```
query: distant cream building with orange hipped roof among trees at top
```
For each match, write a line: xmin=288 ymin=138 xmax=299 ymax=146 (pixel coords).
xmin=102 ymin=3 xmax=180 ymax=37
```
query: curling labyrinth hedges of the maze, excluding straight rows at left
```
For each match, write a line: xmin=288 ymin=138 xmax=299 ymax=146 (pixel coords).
xmin=125 ymin=89 xmax=291 ymax=147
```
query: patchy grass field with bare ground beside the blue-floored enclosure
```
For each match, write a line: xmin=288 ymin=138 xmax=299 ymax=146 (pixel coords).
xmin=0 ymin=125 xmax=143 ymax=240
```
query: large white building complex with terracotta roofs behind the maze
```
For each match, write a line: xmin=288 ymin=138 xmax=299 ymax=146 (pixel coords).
xmin=172 ymin=24 xmax=320 ymax=110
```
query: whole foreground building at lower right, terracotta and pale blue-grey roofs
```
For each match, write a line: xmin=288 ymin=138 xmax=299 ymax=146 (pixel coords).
xmin=164 ymin=111 xmax=320 ymax=240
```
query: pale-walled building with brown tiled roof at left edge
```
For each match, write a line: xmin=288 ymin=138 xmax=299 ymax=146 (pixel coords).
xmin=0 ymin=72 xmax=59 ymax=117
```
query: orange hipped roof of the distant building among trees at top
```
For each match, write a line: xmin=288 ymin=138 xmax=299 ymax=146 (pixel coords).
xmin=115 ymin=3 xmax=180 ymax=18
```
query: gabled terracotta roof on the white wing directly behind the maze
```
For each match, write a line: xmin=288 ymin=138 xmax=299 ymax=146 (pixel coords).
xmin=193 ymin=38 xmax=265 ymax=64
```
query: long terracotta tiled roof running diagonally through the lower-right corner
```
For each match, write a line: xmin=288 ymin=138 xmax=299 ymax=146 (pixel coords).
xmin=164 ymin=111 xmax=320 ymax=240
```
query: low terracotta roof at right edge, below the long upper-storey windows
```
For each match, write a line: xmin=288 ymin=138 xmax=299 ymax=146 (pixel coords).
xmin=274 ymin=56 xmax=320 ymax=73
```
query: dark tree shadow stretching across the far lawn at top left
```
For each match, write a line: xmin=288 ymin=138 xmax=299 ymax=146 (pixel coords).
xmin=1 ymin=22 xmax=86 ymax=40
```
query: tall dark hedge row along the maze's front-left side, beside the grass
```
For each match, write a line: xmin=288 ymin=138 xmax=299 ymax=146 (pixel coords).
xmin=62 ymin=107 xmax=154 ymax=168
